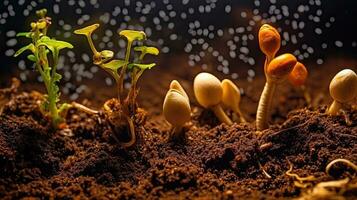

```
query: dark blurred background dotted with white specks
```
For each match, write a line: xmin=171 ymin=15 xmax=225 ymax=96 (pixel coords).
xmin=0 ymin=0 xmax=357 ymax=104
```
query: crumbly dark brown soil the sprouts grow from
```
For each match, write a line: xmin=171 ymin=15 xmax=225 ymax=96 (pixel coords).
xmin=0 ymin=55 xmax=357 ymax=199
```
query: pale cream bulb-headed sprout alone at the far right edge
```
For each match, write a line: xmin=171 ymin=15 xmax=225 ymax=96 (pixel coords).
xmin=327 ymin=69 xmax=357 ymax=115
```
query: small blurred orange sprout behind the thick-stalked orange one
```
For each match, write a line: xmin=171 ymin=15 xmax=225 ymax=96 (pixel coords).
xmin=288 ymin=62 xmax=311 ymax=105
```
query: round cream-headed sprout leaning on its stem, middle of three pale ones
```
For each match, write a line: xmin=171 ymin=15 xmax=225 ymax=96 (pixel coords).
xmin=193 ymin=72 xmax=232 ymax=125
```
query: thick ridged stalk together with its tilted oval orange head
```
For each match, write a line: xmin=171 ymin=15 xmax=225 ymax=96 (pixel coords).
xmin=256 ymin=53 xmax=297 ymax=131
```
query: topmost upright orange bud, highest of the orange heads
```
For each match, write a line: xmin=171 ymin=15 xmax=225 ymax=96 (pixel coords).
xmin=258 ymin=24 xmax=281 ymax=57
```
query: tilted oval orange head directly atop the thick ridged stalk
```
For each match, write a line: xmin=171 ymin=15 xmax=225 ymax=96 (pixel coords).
xmin=267 ymin=53 xmax=297 ymax=79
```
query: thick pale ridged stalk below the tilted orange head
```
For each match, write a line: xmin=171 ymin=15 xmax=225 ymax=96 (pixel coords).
xmin=256 ymin=81 xmax=276 ymax=131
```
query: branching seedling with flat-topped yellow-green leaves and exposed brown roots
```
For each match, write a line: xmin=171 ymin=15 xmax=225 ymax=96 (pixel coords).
xmin=74 ymin=24 xmax=159 ymax=147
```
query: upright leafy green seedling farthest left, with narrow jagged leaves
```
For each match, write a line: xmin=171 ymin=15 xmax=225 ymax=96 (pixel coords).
xmin=14 ymin=9 xmax=73 ymax=128
